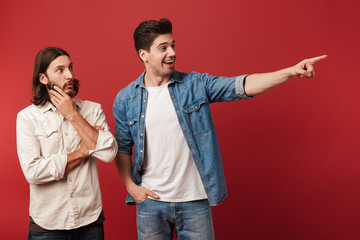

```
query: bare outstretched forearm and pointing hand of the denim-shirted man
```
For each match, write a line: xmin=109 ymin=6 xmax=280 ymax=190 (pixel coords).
xmin=244 ymin=55 xmax=327 ymax=96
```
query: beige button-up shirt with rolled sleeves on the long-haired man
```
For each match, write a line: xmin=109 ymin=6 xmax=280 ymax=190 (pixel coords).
xmin=16 ymin=99 xmax=117 ymax=230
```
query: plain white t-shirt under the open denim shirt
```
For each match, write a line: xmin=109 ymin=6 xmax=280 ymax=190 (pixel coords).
xmin=142 ymin=82 xmax=207 ymax=202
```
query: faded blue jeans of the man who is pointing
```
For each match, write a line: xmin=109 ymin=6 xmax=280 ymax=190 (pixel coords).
xmin=136 ymin=198 xmax=215 ymax=240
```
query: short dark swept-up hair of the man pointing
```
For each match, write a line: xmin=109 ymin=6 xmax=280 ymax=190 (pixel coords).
xmin=133 ymin=18 xmax=172 ymax=58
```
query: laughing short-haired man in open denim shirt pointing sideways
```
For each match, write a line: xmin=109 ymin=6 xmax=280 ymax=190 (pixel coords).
xmin=113 ymin=19 xmax=326 ymax=239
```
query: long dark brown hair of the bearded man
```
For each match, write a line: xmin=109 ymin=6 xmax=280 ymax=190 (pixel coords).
xmin=31 ymin=47 xmax=80 ymax=106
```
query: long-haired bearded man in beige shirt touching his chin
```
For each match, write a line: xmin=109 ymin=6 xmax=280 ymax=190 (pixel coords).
xmin=16 ymin=47 xmax=117 ymax=240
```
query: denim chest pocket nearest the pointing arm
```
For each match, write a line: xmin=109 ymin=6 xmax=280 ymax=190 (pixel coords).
xmin=183 ymin=98 xmax=212 ymax=135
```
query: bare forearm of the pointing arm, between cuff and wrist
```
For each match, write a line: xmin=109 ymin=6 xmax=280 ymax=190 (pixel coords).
xmin=244 ymin=68 xmax=293 ymax=96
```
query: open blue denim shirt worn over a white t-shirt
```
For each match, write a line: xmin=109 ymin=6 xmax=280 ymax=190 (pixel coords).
xmin=113 ymin=71 xmax=252 ymax=206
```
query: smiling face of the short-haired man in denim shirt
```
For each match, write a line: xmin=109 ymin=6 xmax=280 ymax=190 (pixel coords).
xmin=139 ymin=33 xmax=176 ymax=82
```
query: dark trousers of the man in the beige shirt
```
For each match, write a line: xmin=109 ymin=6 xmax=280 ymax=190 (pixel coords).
xmin=28 ymin=223 xmax=104 ymax=240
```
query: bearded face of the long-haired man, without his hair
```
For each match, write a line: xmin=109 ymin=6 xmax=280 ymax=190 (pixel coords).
xmin=40 ymin=55 xmax=76 ymax=97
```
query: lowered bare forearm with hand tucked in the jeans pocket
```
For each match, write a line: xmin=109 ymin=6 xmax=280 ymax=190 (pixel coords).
xmin=115 ymin=153 xmax=159 ymax=203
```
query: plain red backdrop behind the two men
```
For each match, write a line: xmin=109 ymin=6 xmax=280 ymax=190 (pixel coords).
xmin=0 ymin=0 xmax=360 ymax=240
